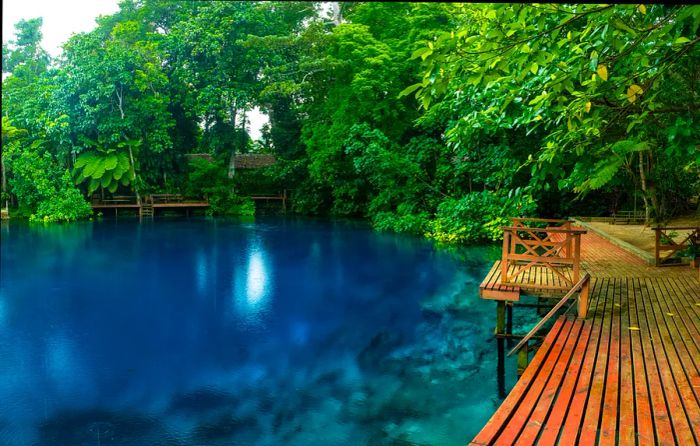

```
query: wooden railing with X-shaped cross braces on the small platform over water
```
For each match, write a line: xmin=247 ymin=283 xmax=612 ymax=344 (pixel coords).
xmin=501 ymin=218 xmax=586 ymax=289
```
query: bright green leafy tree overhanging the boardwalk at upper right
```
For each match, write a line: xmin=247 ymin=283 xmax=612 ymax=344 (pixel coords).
xmin=412 ymin=4 xmax=700 ymax=217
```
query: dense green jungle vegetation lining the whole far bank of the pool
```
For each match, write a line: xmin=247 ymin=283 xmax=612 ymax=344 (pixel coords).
xmin=2 ymin=0 xmax=700 ymax=242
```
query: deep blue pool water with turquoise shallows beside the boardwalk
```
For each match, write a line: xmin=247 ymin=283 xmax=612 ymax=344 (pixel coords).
xmin=0 ymin=218 xmax=515 ymax=446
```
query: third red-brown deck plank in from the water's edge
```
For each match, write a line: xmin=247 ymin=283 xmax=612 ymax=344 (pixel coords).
xmin=516 ymin=319 xmax=587 ymax=445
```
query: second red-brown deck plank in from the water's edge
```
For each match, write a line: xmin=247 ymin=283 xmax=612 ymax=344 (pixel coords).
xmin=495 ymin=318 xmax=574 ymax=446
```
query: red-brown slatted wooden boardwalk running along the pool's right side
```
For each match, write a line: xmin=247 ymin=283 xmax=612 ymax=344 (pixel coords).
xmin=471 ymin=234 xmax=700 ymax=445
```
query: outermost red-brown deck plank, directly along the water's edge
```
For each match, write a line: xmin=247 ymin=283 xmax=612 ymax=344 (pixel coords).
xmin=471 ymin=319 xmax=564 ymax=445
